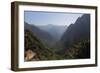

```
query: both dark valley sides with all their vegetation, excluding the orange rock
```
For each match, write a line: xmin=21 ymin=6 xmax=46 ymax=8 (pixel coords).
xmin=24 ymin=14 xmax=90 ymax=61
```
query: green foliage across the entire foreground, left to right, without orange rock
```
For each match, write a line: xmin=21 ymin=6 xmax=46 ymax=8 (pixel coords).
xmin=24 ymin=30 xmax=90 ymax=61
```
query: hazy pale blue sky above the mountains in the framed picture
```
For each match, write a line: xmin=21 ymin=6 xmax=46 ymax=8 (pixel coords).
xmin=24 ymin=11 xmax=83 ymax=26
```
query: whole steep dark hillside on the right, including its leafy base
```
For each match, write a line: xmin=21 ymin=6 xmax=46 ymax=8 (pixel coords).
xmin=58 ymin=14 xmax=90 ymax=58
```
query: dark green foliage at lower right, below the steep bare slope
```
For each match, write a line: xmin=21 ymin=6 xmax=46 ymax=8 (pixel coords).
xmin=64 ymin=40 xmax=90 ymax=59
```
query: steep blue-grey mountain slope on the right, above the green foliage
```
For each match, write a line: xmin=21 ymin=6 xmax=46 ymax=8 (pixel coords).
xmin=60 ymin=14 xmax=90 ymax=51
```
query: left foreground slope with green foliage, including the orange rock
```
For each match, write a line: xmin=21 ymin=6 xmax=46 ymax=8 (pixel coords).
xmin=24 ymin=29 xmax=58 ymax=61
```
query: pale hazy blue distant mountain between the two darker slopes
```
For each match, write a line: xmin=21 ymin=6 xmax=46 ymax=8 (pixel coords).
xmin=37 ymin=24 xmax=67 ymax=40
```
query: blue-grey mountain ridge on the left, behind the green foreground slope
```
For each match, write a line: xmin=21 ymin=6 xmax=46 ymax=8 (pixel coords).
xmin=24 ymin=22 xmax=55 ymax=47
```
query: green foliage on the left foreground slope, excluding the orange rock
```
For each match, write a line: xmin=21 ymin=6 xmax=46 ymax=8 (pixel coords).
xmin=24 ymin=30 xmax=59 ymax=60
